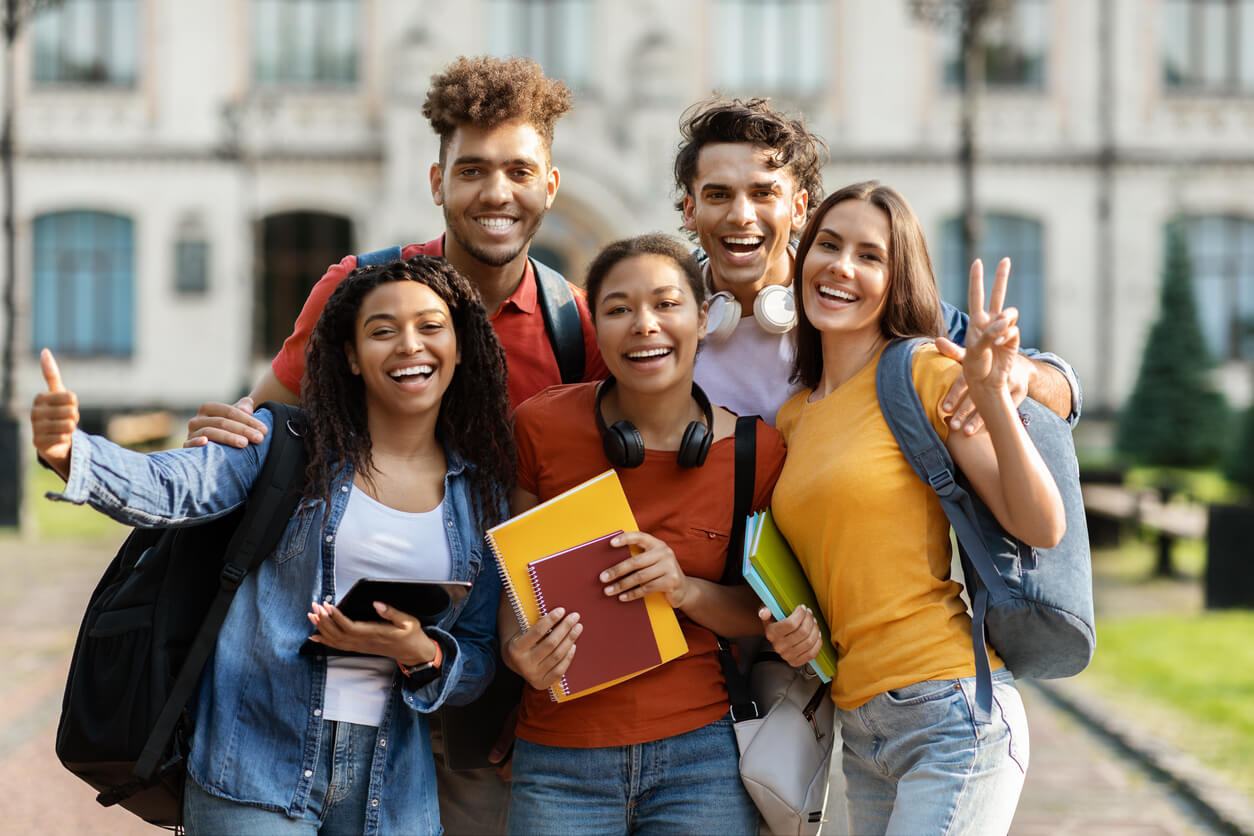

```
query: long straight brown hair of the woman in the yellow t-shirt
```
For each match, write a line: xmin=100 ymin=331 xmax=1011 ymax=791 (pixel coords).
xmin=790 ymin=180 xmax=943 ymax=389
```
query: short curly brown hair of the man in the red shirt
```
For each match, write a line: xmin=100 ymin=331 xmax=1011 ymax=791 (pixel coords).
xmin=423 ymin=56 xmax=571 ymax=168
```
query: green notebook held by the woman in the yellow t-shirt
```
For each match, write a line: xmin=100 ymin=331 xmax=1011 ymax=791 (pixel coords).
xmin=741 ymin=509 xmax=836 ymax=682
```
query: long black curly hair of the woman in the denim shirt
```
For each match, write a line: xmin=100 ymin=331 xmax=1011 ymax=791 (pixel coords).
xmin=301 ymin=256 xmax=517 ymax=528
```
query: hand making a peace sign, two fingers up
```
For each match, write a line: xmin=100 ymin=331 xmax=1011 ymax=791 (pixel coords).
xmin=962 ymin=258 xmax=1020 ymax=406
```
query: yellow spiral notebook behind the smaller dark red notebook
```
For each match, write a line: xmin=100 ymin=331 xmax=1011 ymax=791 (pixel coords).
xmin=488 ymin=470 xmax=688 ymax=702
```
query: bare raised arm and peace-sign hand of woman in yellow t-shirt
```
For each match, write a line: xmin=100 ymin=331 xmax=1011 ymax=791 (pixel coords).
xmin=946 ymin=258 xmax=1066 ymax=548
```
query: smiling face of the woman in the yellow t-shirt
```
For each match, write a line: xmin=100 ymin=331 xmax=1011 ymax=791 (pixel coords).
xmin=801 ymin=199 xmax=892 ymax=338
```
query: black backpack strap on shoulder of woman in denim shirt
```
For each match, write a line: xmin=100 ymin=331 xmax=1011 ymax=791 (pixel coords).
xmin=131 ymin=401 xmax=306 ymax=787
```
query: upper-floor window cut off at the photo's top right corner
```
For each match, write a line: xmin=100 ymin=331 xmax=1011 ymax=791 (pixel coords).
xmin=1162 ymin=0 xmax=1254 ymax=95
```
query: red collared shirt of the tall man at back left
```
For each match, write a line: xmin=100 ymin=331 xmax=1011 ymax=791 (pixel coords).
xmin=270 ymin=236 xmax=609 ymax=406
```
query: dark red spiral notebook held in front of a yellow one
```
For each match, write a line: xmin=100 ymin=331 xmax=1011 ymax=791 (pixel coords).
xmin=527 ymin=531 xmax=662 ymax=696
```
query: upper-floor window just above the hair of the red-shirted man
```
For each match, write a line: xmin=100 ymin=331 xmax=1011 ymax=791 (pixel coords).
xmin=487 ymin=0 xmax=593 ymax=89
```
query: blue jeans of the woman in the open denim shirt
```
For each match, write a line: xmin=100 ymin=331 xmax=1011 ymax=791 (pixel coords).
xmin=183 ymin=721 xmax=379 ymax=836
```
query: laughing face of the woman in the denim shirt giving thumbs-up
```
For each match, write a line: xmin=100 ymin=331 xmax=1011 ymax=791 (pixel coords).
xmin=345 ymin=282 xmax=461 ymax=415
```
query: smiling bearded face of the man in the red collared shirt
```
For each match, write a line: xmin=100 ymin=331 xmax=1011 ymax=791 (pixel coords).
xmin=430 ymin=120 xmax=558 ymax=267
